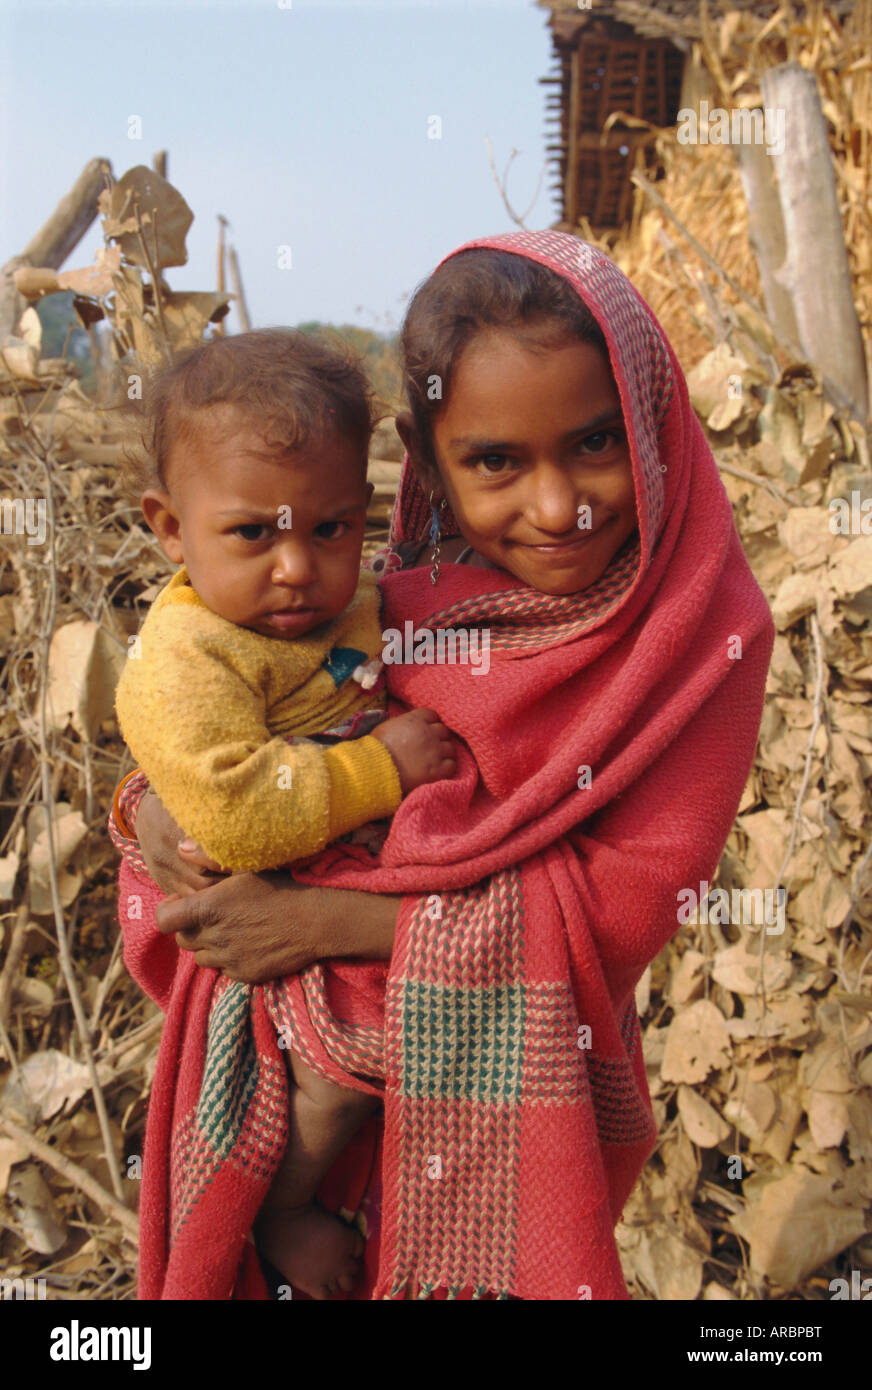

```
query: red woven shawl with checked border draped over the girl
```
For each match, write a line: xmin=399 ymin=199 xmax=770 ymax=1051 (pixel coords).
xmin=114 ymin=232 xmax=773 ymax=1298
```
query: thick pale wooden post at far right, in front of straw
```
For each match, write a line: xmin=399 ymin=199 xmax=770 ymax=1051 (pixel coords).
xmin=761 ymin=63 xmax=869 ymax=424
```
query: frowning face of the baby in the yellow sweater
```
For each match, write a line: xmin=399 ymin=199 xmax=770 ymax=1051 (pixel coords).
xmin=161 ymin=407 xmax=371 ymax=638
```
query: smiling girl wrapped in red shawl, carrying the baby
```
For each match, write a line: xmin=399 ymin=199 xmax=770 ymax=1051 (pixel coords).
xmin=112 ymin=232 xmax=773 ymax=1298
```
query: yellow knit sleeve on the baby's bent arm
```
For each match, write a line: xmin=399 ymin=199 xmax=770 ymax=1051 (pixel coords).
xmin=115 ymin=607 xmax=402 ymax=872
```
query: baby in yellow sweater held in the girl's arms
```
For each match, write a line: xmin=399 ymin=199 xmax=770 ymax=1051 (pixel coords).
xmin=115 ymin=329 xmax=456 ymax=1298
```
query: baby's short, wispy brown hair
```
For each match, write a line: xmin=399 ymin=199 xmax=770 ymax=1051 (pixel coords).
xmin=124 ymin=328 xmax=374 ymax=493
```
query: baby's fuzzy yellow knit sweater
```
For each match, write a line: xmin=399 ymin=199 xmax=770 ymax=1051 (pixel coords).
xmin=115 ymin=567 xmax=402 ymax=872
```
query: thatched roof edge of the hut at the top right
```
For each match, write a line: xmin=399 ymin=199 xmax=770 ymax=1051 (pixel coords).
xmin=535 ymin=0 xmax=854 ymax=47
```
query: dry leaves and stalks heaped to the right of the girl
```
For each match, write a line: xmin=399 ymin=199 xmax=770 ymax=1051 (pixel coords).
xmin=606 ymin=7 xmax=872 ymax=1300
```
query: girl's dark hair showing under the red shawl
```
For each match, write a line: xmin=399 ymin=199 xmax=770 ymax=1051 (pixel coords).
xmin=401 ymin=246 xmax=608 ymax=468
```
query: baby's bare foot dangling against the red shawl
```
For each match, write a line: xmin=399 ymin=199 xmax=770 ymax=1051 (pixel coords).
xmin=256 ymin=1202 xmax=363 ymax=1298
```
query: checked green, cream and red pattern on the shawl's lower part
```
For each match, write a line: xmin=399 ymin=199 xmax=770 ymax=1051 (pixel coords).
xmin=162 ymin=867 xmax=652 ymax=1297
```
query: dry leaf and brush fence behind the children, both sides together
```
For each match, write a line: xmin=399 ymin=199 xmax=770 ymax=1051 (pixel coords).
xmin=0 ymin=48 xmax=872 ymax=1301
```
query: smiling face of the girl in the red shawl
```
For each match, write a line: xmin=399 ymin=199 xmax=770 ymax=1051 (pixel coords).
xmin=411 ymin=329 xmax=637 ymax=595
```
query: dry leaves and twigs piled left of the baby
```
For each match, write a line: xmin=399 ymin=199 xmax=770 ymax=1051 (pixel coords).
xmin=0 ymin=170 xmax=402 ymax=1298
